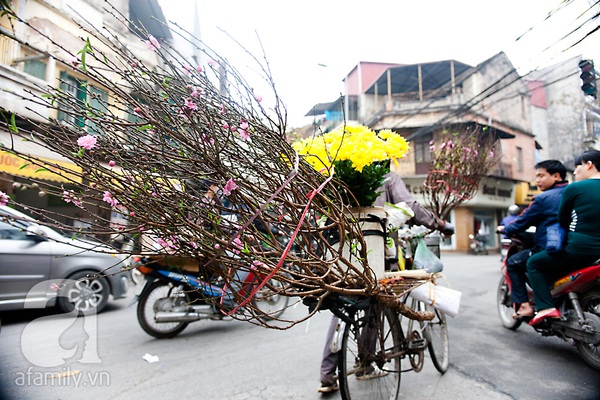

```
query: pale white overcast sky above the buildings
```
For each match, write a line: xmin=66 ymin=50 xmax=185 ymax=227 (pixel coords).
xmin=159 ymin=0 xmax=600 ymax=127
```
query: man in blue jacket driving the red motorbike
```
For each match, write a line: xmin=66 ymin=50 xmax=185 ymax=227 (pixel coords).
xmin=497 ymin=160 xmax=567 ymax=318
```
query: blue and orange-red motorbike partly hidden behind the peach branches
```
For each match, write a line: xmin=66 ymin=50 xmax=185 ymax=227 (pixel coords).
xmin=135 ymin=257 xmax=289 ymax=339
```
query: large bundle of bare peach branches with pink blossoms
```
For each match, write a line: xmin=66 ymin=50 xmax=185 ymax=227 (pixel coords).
xmin=2 ymin=3 xmax=422 ymax=327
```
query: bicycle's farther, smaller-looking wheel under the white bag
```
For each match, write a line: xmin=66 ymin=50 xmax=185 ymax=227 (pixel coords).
xmin=421 ymin=303 xmax=450 ymax=374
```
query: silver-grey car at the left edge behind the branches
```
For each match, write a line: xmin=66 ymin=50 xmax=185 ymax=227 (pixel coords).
xmin=0 ymin=206 xmax=130 ymax=312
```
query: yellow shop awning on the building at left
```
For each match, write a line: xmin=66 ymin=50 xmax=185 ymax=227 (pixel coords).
xmin=0 ymin=132 xmax=82 ymax=183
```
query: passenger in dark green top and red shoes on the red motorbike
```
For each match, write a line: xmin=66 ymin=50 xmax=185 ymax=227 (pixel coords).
xmin=527 ymin=150 xmax=600 ymax=325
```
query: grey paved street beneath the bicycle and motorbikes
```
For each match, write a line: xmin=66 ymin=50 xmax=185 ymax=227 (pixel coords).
xmin=0 ymin=253 xmax=600 ymax=400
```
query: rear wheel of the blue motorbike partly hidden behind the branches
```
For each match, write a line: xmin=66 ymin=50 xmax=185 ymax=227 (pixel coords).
xmin=137 ymin=281 xmax=189 ymax=339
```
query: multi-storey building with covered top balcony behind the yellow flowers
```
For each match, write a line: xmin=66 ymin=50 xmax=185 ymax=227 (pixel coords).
xmin=310 ymin=53 xmax=537 ymax=251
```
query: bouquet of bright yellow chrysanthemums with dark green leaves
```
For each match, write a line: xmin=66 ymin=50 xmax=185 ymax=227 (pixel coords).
xmin=293 ymin=125 xmax=409 ymax=206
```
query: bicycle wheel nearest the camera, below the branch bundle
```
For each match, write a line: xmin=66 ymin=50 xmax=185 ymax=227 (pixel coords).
xmin=338 ymin=304 xmax=402 ymax=400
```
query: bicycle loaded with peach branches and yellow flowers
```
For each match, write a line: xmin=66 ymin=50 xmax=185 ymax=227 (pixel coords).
xmin=328 ymin=268 xmax=449 ymax=400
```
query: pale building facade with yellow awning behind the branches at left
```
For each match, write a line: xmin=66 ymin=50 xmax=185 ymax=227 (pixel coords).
xmin=0 ymin=0 xmax=171 ymax=238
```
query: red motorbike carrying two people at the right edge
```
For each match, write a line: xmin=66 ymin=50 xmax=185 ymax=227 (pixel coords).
xmin=497 ymin=238 xmax=600 ymax=370
